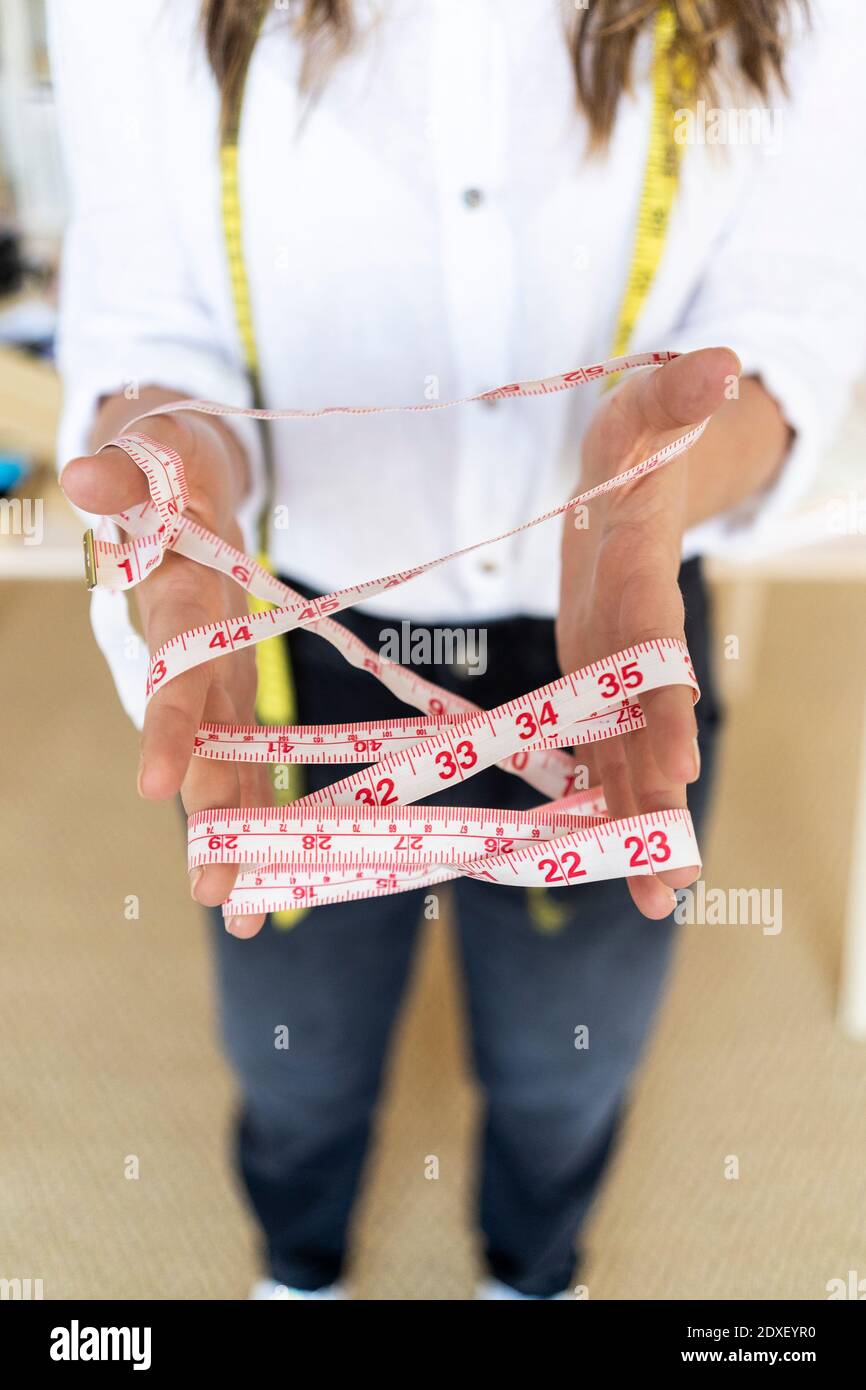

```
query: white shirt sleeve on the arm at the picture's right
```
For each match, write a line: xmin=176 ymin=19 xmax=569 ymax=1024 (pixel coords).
xmin=673 ymin=0 xmax=866 ymax=555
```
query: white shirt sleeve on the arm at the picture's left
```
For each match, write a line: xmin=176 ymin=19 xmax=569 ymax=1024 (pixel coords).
xmin=49 ymin=0 xmax=264 ymax=525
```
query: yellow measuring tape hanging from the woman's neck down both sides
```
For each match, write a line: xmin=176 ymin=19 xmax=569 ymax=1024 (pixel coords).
xmin=220 ymin=3 xmax=694 ymax=931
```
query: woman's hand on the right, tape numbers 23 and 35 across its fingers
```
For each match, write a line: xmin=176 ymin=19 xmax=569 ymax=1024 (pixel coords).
xmin=556 ymin=348 xmax=740 ymax=917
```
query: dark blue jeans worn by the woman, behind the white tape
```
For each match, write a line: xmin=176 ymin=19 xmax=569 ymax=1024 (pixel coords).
xmin=207 ymin=562 xmax=719 ymax=1295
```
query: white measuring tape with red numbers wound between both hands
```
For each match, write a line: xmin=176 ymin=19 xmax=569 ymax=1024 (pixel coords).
xmin=85 ymin=352 xmax=706 ymax=916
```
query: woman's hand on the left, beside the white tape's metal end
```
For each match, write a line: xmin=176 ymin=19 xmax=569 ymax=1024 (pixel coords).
xmin=61 ymin=405 xmax=271 ymax=937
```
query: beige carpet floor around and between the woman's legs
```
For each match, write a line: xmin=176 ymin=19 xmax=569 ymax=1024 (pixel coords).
xmin=0 ymin=584 xmax=866 ymax=1300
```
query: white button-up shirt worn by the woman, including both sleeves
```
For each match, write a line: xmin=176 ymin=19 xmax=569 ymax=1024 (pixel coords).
xmin=50 ymin=0 xmax=866 ymax=717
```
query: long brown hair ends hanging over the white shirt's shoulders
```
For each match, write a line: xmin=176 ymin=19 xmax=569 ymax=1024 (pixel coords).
xmin=202 ymin=0 xmax=809 ymax=149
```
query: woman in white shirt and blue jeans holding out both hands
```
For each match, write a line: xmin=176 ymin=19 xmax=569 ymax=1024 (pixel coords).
xmin=51 ymin=0 xmax=866 ymax=1298
